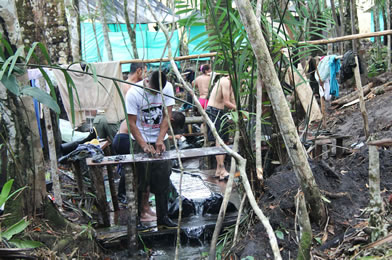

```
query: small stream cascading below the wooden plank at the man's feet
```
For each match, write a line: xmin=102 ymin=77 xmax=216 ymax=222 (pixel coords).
xmin=98 ymin=159 xmax=240 ymax=259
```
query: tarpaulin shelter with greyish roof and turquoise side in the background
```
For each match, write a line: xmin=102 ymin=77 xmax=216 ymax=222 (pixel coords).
xmin=79 ymin=0 xmax=207 ymax=71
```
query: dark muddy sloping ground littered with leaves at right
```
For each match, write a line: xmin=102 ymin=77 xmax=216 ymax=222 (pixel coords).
xmin=235 ymin=83 xmax=392 ymax=259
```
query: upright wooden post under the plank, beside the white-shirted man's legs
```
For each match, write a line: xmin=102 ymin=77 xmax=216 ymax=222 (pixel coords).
xmin=123 ymin=164 xmax=138 ymax=256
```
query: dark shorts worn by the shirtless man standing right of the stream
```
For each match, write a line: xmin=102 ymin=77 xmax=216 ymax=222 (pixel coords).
xmin=206 ymin=106 xmax=229 ymax=142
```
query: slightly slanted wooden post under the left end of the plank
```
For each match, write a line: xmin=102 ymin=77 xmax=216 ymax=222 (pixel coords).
xmin=90 ymin=166 xmax=110 ymax=227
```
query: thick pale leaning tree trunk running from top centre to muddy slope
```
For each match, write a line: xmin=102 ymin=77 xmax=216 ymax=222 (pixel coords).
xmin=235 ymin=0 xmax=327 ymax=225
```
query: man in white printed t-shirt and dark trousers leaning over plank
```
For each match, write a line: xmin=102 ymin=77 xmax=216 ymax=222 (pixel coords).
xmin=126 ymin=71 xmax=177 ymax=229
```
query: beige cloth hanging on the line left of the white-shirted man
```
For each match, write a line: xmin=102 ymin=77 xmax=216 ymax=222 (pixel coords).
xmin=53 ymin=62 xmax=125 ymax=127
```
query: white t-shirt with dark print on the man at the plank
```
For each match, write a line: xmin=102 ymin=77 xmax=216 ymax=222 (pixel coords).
xmin=125 ymin=81 xmax=175 ymax=143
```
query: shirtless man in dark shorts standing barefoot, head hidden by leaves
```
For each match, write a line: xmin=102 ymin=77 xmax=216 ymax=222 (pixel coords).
xmin=206 ymin=76 xmax=237 ymax=180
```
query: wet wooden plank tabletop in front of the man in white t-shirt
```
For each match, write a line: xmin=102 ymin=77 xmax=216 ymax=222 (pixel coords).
xmin=87 ymin=147 xmax=227 ymax=166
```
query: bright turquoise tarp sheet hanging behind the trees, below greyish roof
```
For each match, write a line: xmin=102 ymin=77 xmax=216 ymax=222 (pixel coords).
xmin=80 ymin=23 xmax=207 ymax=71
